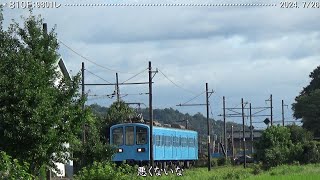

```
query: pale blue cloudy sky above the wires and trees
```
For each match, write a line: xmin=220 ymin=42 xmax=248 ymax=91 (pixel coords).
xmin=0 ymin=0 xmax=320 ymax=129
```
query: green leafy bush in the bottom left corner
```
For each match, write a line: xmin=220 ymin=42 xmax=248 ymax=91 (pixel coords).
xmin=0 ymin=151 xmax=34 ymax=180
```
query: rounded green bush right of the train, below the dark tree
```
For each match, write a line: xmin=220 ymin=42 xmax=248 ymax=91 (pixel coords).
xmin=256 ymin=125 xmax=320 ymax=167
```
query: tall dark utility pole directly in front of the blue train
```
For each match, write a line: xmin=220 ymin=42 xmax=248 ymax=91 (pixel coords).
xmin=148 ymin=61 xmax=154 ymax=174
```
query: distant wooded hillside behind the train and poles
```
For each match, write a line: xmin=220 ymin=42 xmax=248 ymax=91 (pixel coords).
xmin=89 ymin=104 xmax=247 ymax=137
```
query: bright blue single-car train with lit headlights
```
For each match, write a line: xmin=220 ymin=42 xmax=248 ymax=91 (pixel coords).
xmin=110 ymin=123 xmax=198 ymax=166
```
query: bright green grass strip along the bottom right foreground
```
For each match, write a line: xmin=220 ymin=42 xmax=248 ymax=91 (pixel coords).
xmin=132 ymin=164 xmax=320 ymax=180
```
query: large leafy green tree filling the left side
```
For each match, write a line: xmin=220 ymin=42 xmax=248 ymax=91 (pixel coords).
xmin=0 ymin=12 xmax=85 ymax=175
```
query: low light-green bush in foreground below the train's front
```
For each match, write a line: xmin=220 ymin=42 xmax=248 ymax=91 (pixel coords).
xmin=74 ymin=162 xmax=136 ymax=180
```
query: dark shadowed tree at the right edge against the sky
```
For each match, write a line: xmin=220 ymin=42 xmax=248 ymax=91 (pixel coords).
xmin=292 ymin=66 xmax=320 ymax=136
